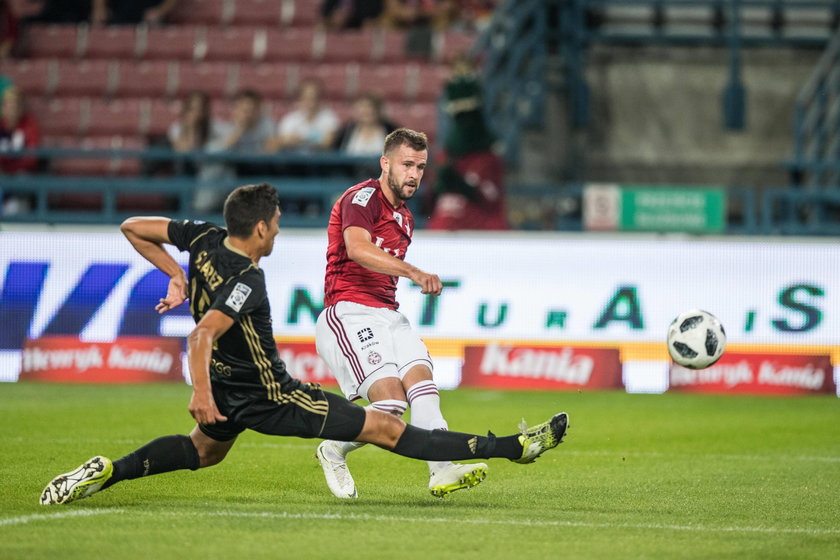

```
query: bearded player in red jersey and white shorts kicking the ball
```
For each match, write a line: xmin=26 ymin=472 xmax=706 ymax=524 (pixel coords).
xmin=316 ymin=128 xmax=487 ymax=498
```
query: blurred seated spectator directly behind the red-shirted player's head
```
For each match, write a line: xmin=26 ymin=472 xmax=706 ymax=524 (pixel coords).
xmin=331 ymin=93 xmax=397 ymax=156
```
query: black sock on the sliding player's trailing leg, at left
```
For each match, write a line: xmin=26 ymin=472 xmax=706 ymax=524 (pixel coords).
xmin=102 ymin=435 xmax=198 ymax=490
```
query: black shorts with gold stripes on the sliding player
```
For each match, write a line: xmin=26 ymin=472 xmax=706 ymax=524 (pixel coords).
xmin=199 ymin=379 xmax=365 ymax=441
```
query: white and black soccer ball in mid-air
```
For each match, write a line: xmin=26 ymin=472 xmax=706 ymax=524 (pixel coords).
xmin=668 ymin=309 xmax=726 ymax=369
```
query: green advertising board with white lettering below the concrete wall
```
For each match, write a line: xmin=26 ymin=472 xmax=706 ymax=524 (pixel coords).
xmin=618 ymin=185 xmax=726 ymax=233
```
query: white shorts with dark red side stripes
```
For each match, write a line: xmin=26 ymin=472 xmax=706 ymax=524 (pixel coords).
xmin=315 ymin=301 xmax=432 ymax=401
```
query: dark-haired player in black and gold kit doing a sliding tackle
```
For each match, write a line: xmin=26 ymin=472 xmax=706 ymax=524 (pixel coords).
xmin=40 ymin=184 xmax=568 ymax=505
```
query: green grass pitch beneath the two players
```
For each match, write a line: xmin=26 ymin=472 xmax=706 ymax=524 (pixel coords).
xmin=0 ymin=383 xmax=840 ymax=560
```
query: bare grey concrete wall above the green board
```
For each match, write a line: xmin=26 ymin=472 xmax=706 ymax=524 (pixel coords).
xmin=568 ymin=45 xmax=821 ymax=187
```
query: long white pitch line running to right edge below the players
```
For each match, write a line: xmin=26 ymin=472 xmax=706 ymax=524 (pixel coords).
xmin=171 ymin=511 xmax=840 ymax=535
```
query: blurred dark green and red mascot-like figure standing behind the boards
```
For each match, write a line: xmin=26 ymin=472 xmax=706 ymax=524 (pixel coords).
xmin=426 ymin=62 xmax=509 ymax=230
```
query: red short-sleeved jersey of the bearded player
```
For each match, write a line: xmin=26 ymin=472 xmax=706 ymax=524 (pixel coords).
xmin=324 ymin=179 xmax=414 ymax=309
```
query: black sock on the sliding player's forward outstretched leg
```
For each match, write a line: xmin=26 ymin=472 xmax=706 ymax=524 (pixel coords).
xmin=391 ymin=425 xmax=522 ymax=461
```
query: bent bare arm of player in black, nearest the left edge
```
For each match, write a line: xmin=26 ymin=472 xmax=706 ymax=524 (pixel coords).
xmin=120 ymin=216 xmax=187 ymax=313
